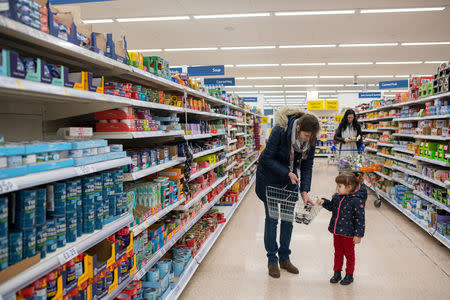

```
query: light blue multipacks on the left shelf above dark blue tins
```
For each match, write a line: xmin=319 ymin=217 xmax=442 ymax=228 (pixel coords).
xmin=0 ymin=140 xmax=126 ymax=179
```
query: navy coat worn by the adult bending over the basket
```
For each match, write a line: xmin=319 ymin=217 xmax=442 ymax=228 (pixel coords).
xmin=255 ymin=108 xmax=315 ymax=202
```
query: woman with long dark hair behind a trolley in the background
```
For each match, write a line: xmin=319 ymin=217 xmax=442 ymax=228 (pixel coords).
xmin=334 ymin=109 xmax=362 ymax=155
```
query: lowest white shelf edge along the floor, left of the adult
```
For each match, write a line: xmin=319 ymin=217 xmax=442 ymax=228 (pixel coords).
xmin=166 ymin=177 xmax=255 ymax=300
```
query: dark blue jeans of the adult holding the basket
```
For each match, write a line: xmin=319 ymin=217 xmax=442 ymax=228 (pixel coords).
xmin=264 ymin=184 xmax=298 ymax=265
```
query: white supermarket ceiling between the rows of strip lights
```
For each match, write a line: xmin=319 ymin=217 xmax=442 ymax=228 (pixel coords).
xmin=68 ymin=0 xmax=450 ymax=105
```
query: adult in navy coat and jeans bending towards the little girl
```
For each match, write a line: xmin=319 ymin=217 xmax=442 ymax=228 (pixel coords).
xmin=256 ymin=107 xmax=320 ymax=278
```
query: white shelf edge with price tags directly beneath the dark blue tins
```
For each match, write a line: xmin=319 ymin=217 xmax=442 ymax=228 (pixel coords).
xmin=0 ymin=214 xmax=133 ymax=296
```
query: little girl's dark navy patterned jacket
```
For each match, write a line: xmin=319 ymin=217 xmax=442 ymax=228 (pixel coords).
xmin=323 ymin=184 xmax=367 ymax=237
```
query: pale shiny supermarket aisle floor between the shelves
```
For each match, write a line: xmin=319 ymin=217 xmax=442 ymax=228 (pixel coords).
xmin=180 ymin=159 xmax=450 ymax=300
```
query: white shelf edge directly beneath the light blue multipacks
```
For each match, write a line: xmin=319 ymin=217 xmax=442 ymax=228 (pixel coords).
xmin=0 ymin=157 xmax=131 ymax=195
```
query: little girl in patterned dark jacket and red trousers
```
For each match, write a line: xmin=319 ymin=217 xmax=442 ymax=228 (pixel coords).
xmin=319 ymin=173 xmax=367 ymax=285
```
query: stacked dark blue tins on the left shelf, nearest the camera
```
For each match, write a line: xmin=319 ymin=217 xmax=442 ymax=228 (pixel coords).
xmin=0 ymin=169 xmax=127 ymax=269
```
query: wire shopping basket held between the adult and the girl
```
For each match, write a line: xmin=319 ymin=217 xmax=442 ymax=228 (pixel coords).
xmin=266 ymin=185 xmax=322 ymax=225
